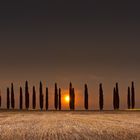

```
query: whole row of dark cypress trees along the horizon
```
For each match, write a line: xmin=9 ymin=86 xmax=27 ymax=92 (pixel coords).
xmin=0 ymin=81 xmax=135 ymax=110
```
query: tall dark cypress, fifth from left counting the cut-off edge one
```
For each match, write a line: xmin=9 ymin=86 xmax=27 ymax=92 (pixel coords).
xmin=25 ymin=81 xmax=29 ymax=109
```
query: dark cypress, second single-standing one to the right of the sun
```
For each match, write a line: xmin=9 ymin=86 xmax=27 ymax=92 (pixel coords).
xmin=99 ymin=84 xmax=104 ymax=110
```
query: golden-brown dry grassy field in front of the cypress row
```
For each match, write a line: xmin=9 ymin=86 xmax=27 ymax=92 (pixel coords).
xmin=0 ymin=111 xmax=140 ymax=140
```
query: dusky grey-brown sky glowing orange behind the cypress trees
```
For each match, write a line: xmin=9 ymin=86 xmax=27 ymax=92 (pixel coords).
xmin=0 ymin=0 xmax=140 ymax=109
